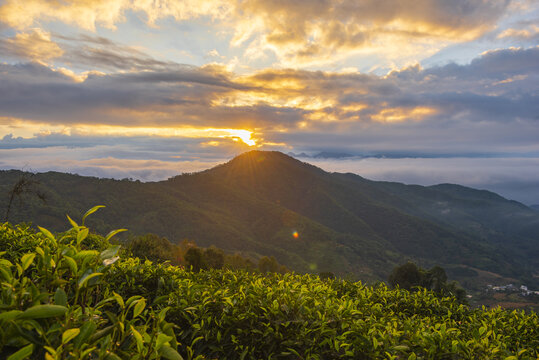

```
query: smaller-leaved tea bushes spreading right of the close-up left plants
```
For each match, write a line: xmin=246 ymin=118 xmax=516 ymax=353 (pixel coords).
xmin=103 ymin=260 xmax=539 ymax=359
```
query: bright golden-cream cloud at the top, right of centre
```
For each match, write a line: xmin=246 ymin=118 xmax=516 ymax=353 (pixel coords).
xmin=233 ymin=0 xmax=509 ymax=66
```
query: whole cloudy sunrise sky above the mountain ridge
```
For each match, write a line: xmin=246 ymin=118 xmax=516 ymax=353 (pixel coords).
xmin=0 ymin=0 xmax=539 ymax=205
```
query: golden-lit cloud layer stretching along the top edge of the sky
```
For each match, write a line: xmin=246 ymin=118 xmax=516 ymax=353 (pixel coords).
xmin=0 ymin=0 xmax=511 ymax=67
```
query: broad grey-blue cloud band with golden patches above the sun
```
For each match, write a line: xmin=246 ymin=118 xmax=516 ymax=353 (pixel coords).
xmin=0 ymin=45 xmax=539 ymax=161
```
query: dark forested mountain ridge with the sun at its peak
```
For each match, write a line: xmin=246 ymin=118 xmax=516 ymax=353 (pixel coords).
xmin=0 ymin=151 xmax=539 ymax=287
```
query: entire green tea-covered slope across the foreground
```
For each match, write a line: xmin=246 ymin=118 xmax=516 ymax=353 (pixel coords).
xmin=0 ymin=212 xmax=539 ymax=360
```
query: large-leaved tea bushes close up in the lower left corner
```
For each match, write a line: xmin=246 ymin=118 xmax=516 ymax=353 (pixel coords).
xmin=0 ymin=211 xmax=181 ymax=360
